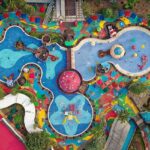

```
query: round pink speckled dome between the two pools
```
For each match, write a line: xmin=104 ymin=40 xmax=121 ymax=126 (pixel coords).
xmin=58 ymin=69 xmax=82 ymax=94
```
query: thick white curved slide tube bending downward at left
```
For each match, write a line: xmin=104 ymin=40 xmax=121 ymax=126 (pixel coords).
xmin=0 ymin=93 xmax=42 ymax=133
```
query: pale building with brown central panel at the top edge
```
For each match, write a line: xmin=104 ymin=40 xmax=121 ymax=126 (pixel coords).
xmin=26 ymin=0 xmax=84 ymax=24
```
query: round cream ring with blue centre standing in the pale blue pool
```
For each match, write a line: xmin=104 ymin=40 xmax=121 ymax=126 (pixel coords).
xmin=110 ymin=44 xmax=125 ymax=59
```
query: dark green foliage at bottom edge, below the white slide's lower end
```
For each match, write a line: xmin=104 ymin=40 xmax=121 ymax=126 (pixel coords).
xmin=25 ymin=131 xmax=56 ymax=150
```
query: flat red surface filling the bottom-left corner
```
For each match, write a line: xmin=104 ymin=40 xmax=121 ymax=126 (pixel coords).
xmin=0 ymin=121 xmax=25 ymax=150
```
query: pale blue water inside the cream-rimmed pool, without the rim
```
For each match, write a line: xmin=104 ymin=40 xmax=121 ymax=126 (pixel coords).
xmin=75 ymin=27 xmax=150 ymax=80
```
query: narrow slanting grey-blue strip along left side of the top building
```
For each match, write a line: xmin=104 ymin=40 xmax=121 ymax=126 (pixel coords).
xmin=43 ymin=0 xmax=55 ymax=25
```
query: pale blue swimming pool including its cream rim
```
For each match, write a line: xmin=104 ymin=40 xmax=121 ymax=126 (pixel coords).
xmin=72 ymin=27 xmax=150 ymax=81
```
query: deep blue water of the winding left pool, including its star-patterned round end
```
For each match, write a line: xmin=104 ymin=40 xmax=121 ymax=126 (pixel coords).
xmin=0 ymin=27 xmax=93 ymax=136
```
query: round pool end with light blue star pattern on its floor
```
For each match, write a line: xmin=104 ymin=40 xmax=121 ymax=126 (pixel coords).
xmin=48 ymin=94 xmax=93 ymax=137
